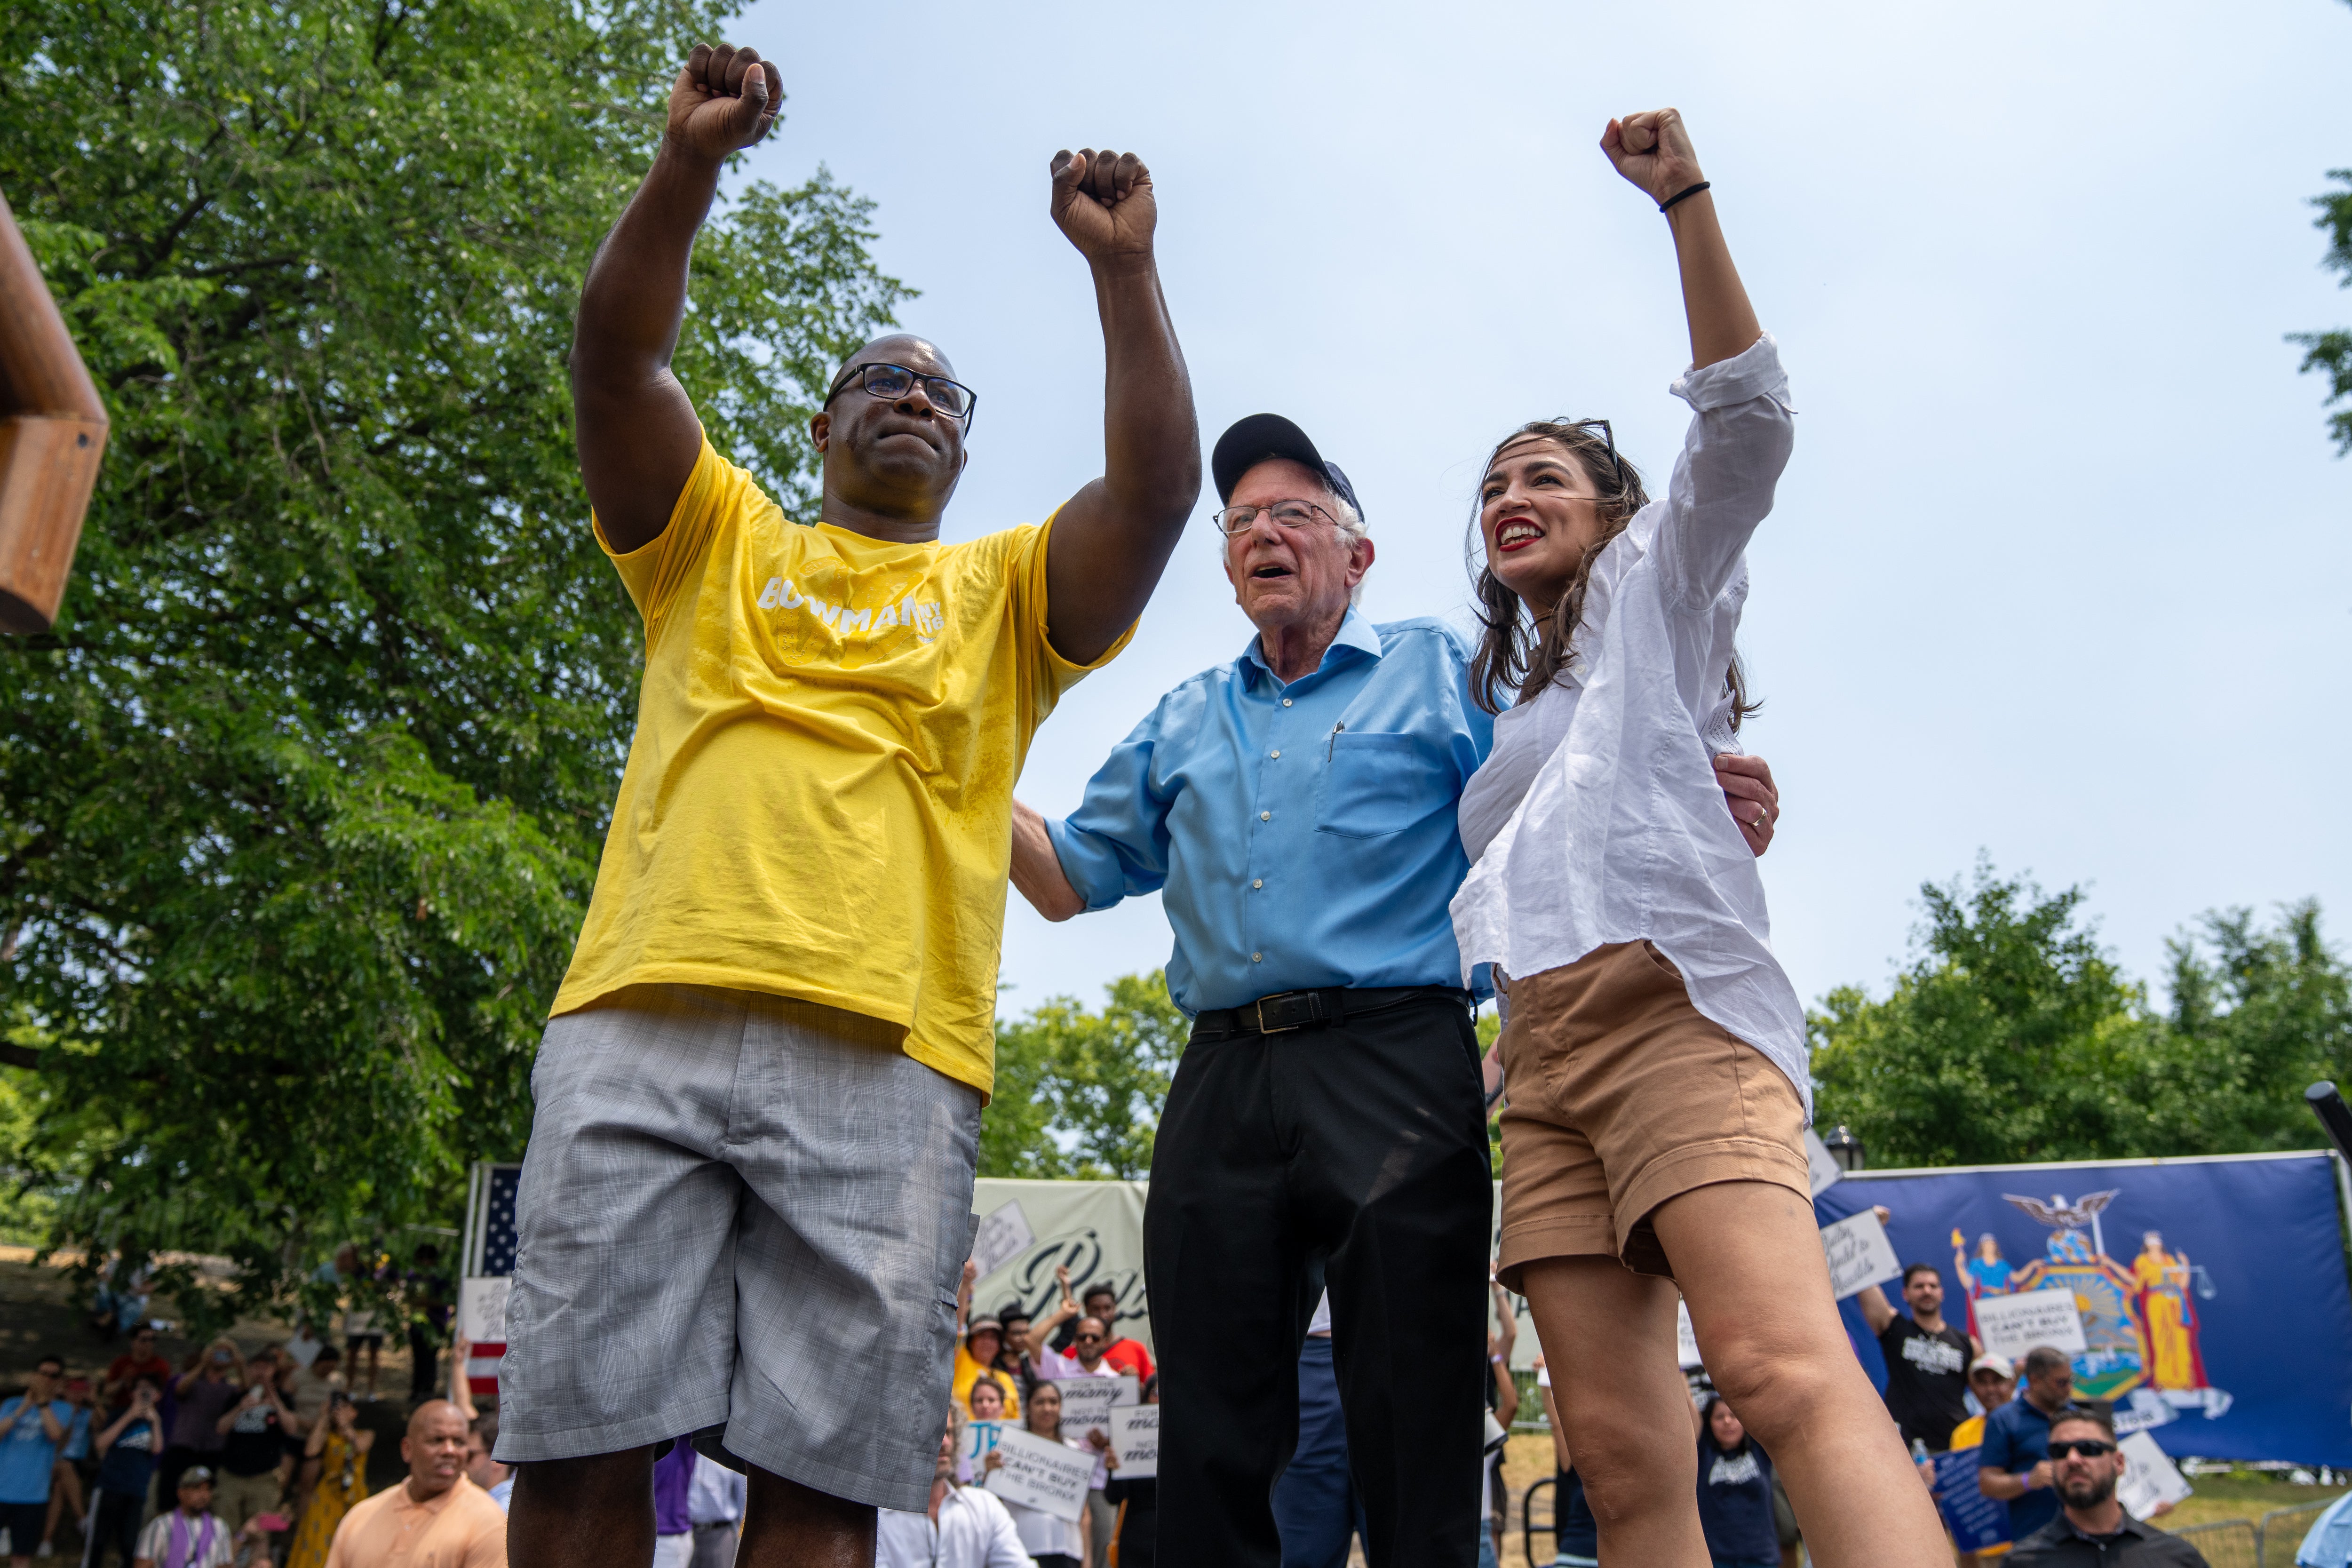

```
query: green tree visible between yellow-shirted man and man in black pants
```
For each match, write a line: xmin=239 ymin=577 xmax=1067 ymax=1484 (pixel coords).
xmin=981 ymin=969 xmax=1190 ymax=1180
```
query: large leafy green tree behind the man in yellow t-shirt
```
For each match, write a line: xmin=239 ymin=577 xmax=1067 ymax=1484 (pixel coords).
xmin=0 ymin=0 xmax=908 ymax=1316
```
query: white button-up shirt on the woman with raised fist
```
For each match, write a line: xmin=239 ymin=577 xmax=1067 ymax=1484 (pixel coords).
xmin=1454 ymin=334 xmax=1813 ymax=1114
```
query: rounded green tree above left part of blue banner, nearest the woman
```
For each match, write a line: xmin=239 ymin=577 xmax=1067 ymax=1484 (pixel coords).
xmin=1809 ymin=863 xmax=2147 ymax=1166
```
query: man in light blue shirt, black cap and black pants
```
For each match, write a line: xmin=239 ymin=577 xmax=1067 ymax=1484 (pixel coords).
xmin=1011 ymin=414 xmax=1776 ymax=1568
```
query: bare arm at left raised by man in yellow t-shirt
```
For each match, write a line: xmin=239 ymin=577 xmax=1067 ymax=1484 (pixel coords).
xmin=572 ymin=45 xmax=783 ymax=552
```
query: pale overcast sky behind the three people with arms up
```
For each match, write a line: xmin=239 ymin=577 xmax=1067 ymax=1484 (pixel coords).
xmin=734 ymin=0 xmax=2352 ymax=1013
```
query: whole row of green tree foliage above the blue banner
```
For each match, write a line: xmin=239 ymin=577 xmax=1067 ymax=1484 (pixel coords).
xmin=1811 ymin=865 xmax=2352 ymax=1166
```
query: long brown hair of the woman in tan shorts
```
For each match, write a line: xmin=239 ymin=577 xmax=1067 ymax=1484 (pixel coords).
xmin=1465 ymin=418 xmax=1764 ymax=731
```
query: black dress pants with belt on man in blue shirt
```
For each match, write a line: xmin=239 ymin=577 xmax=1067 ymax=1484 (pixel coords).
xmin=1143 ymin=992 xmax=1494 ymax=1568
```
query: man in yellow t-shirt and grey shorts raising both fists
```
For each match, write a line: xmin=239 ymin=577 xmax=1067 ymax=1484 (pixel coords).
xmin=496 ymin=47 xmax=1200 ymax=1568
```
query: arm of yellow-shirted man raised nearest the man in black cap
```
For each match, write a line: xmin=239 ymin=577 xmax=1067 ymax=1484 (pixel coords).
xmin=1044 ymin=148 xmax=1200 ymax=665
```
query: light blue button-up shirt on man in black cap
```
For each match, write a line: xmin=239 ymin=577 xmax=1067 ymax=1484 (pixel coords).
xmin=1047 ymin=609 xmax=1494 ymax=1013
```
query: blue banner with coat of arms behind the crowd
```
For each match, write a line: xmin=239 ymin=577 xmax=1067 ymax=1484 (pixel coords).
xmin=1813 ymin=1154 xmax=2352 ymax=1465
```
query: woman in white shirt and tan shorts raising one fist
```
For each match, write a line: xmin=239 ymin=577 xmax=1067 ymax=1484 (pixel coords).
xmin=1454 ymin=108 xmax=1947 ymax=1568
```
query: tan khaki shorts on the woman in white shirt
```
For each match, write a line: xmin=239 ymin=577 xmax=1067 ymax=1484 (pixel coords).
xmin=1496 ymin=943 xmax=1811 ymax=1290
